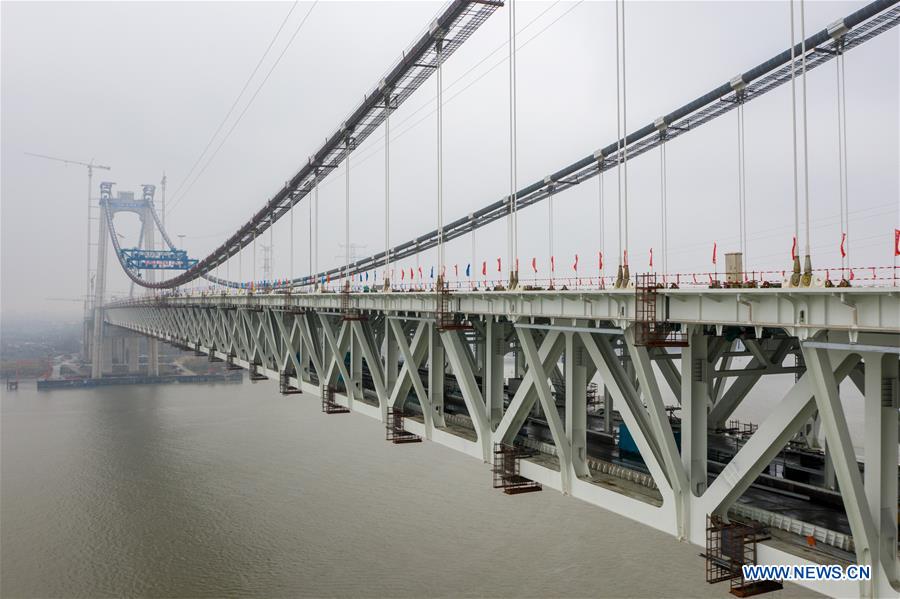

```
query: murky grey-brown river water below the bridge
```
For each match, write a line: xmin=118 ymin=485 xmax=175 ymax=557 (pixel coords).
xmin=0 ymin=381 xmax=812 ymax=597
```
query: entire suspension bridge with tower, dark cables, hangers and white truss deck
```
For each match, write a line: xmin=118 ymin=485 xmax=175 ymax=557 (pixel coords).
xmin=77 ymin=0 xmax=900 ymax=597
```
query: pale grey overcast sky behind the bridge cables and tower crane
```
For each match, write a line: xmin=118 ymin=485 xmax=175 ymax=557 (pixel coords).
xmin=0 ymin=2 xmax=900 ymax=319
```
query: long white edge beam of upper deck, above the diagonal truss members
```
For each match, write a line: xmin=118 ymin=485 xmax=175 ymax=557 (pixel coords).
xmin=110 ymin=287 xmax=900 ymax=342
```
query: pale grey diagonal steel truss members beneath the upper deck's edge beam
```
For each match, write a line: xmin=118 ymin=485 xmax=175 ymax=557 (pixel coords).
xmin=107 ymin=303 xmax=900 ymax=596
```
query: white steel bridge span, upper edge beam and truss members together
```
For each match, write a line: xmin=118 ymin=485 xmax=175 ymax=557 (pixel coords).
xmin=105 ymin=288 xmax=900 ymax=597
